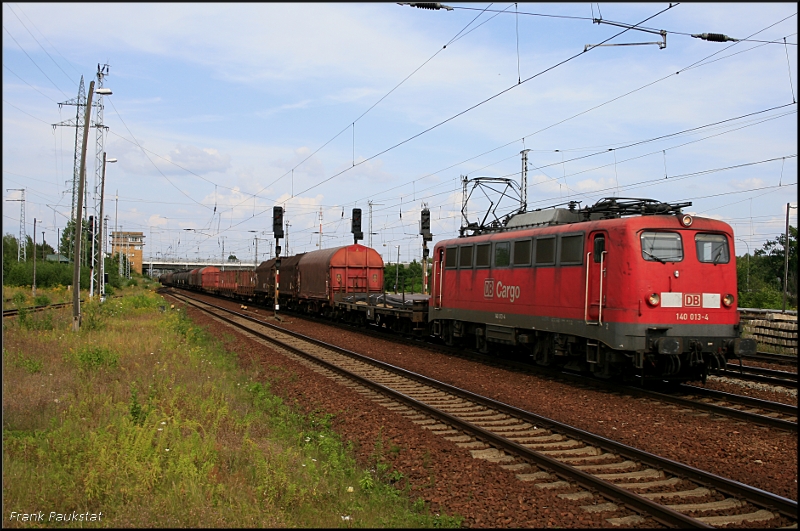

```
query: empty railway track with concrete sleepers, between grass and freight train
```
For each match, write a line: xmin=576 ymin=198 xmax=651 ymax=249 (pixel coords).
xmin=169 ymin=288 xmax=797 ymax=527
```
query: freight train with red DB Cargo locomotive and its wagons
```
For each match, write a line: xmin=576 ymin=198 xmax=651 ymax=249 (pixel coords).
xmin=161 ymin=198 xmax=756 ymax=382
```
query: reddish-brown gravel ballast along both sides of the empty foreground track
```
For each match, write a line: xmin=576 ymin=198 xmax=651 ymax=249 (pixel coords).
xmin=173 ymin=299 xmax=797 ymax=527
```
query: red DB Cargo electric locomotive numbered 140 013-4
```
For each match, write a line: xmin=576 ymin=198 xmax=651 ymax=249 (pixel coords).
xmin=429 ymin=198 xmax=756 ymax=381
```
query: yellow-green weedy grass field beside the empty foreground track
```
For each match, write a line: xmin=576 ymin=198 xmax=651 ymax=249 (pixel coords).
xmin=3 ymin=283 xmax=460 ymax=527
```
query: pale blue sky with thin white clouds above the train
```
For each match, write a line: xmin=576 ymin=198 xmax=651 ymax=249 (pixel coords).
xmin=3 ymin=3 xmax=798 ymax=261
